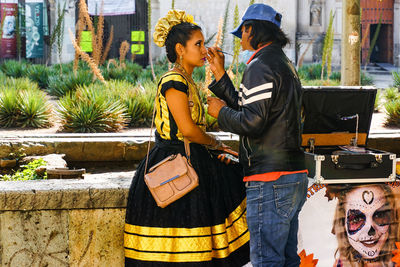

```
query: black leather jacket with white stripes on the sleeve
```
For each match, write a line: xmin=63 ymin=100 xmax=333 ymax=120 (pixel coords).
xmin=209 ymin=44 xmax=305 ymax=176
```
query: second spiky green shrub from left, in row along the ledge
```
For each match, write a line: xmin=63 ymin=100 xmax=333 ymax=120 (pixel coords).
xmin=58 ymin=84 xmax=127 ymax=133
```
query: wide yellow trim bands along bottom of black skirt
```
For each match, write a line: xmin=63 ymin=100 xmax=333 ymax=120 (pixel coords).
xmin=124 ymin=199 xmax=250 ymax=262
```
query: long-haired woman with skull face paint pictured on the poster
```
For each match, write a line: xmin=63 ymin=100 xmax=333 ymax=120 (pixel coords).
xmin=332 ymin=184 xmax=398 ymax=267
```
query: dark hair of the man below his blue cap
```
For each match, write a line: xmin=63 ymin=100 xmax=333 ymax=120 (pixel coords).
xmin=243 ymin=17 xmax=290 ymax=49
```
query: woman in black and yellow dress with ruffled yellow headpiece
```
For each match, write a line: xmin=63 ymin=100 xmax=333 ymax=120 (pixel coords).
xmin=124 ymin=10 xmax=249 ymax=266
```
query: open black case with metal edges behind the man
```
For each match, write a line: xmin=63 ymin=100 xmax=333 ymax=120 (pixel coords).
xmin=302 ymin=87 xmax=396 ymax=184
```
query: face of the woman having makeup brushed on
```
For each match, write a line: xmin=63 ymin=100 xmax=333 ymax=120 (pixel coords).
xmin=182 ymin=30 xmax=207 ymax=67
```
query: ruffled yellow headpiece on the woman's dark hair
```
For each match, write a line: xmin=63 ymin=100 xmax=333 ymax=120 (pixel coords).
xmin=153 ymin=9 xmax=194 ymax=47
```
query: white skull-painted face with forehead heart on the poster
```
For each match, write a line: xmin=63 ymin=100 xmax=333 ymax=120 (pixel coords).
xmin=344 ymin=186 xmax=392 ymax=259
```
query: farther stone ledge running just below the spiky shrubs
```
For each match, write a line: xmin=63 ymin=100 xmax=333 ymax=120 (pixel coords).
xmin=0 ymin=132 xmax=239 ymax=161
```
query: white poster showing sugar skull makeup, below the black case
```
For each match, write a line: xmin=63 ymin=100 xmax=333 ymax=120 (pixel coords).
xmin=298 ymin=180 xmax=400 ymax=267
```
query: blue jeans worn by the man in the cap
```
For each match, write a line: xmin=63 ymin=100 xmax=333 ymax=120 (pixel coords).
xmin=246 ymin=173 xmax=308 ymax=267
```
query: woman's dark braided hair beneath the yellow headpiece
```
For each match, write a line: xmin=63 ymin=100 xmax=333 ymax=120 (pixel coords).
xmin=165 ymin=22 xmax=201 ymax=63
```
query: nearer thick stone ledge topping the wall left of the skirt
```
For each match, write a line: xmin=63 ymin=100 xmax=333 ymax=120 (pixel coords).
xmin=0 ymin=177 xmax=132 ymax=211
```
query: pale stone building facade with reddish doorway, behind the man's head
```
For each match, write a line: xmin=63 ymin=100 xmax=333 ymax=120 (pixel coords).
xmin=152 ymin=0 xmax=400 ymax=66
